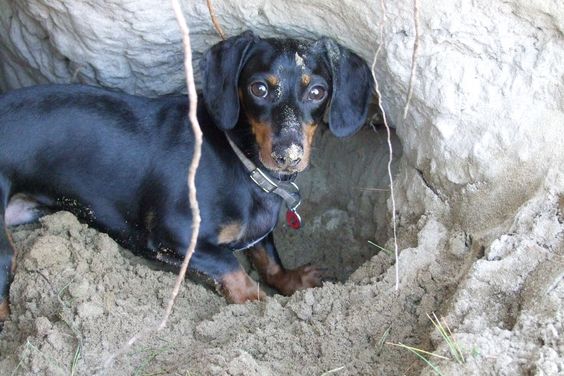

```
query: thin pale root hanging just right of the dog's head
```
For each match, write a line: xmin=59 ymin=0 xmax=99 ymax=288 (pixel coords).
xmin=372 ymin=0 xmax=399 ymax=291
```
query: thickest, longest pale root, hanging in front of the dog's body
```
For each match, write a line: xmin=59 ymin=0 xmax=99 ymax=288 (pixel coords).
xmin=104 ymin=0 xmax=202 ymax=368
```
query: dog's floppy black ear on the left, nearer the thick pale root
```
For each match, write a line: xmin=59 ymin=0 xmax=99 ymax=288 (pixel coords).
xmin=200 ymin=31 xmax=257 ymax=130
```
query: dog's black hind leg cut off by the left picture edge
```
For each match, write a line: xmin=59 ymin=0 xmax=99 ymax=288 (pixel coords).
xmin=0 ymin=181 xmax=16 ymax=322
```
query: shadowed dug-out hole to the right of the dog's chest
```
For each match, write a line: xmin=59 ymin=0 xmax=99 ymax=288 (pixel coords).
xmin=268 ymin=127 xmax=401 ymax=281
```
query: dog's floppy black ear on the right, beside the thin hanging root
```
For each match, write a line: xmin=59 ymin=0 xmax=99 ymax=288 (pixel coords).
xmin=314 ymin=38 xmax=374 ymax=137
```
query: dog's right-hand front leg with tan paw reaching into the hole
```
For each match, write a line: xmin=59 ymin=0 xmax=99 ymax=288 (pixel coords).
xmin=249 ymin=233 xmax=323 ymax=295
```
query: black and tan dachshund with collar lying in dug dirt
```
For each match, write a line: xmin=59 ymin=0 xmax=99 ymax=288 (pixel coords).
xmin=0 ymin=32 xmax=372 ymax=319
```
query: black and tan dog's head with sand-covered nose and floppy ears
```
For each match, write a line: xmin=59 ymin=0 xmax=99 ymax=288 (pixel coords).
xmin=201 ymin=32 xmax=372 ymax=173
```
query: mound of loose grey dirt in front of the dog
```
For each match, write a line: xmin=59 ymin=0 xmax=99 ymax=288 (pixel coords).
xmin=0 ymin=212 xmax=446 ymax=375
